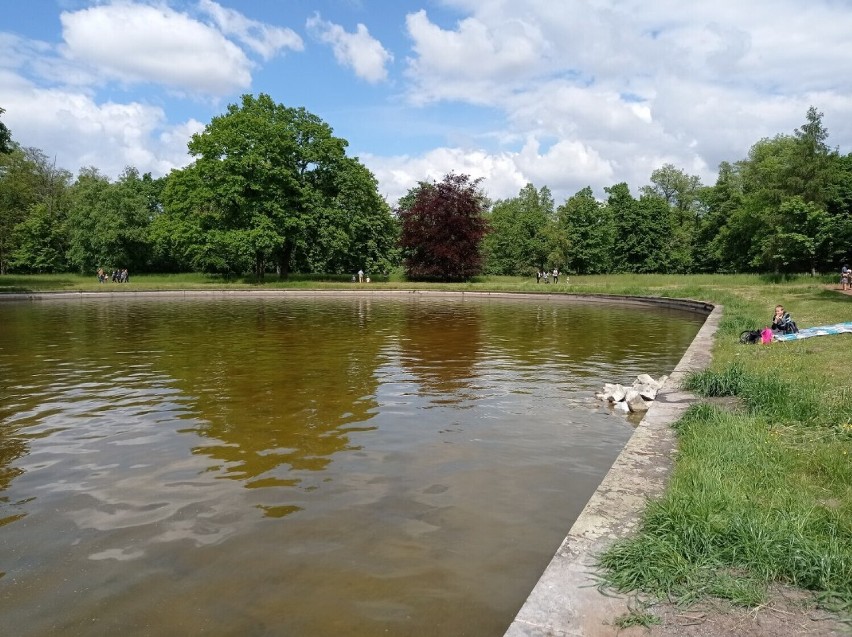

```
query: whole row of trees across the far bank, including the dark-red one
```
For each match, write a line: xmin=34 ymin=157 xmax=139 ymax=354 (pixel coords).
xmin=0 ymin=94 xmax=852 ymax=280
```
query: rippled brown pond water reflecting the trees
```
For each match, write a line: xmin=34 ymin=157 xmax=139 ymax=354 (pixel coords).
xmin=0 ymin=298 xmax=703 ymax=636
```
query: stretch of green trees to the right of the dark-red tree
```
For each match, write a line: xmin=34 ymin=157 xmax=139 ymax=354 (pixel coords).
xmin=485 ymin=107 xmax=852 ymax=274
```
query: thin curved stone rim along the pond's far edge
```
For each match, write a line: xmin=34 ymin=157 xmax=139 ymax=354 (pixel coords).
xmin=0 ymin=289 xmax=714 ymax=315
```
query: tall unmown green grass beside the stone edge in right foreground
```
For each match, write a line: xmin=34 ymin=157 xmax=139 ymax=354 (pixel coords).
xmin=600 ymin=362 xmax=852 ymax=613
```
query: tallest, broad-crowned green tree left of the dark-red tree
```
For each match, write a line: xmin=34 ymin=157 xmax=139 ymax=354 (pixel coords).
xmin=163 ymin=94 xmax=395 ymax=276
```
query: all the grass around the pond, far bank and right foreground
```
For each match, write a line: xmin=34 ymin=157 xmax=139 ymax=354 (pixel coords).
xmin=5 ymin=274 xmax=852 ymax=615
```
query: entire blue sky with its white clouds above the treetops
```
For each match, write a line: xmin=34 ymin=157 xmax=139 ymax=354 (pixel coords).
xmin=0 ymin=0 xmax=852 ymax=204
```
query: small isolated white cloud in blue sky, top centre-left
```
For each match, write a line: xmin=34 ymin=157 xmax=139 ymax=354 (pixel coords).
xmin=306 ymin=14 xmax=393 ymax=84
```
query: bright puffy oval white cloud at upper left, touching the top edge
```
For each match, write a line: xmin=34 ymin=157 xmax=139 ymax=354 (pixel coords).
xmin=60 ymin=2 xmax=252 ymax=95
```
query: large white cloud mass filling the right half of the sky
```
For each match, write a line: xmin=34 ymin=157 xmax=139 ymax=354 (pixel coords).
xmin=390 ymin=0 xmax=852 ymax=200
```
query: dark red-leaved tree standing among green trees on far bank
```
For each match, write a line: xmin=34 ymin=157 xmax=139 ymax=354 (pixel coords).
xmin=398 ymin=173 xmax=488 ymax=281
